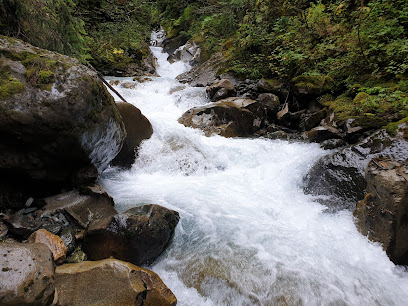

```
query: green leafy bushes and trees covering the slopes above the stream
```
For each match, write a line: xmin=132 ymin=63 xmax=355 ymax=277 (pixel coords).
xmin=0 ymin=0 xmax=408 ymax=126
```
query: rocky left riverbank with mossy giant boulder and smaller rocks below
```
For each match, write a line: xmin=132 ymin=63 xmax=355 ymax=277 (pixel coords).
xmin=0 ymin=36 xmax=179 ymax=305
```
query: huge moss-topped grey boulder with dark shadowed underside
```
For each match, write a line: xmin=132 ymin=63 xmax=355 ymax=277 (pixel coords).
xmin=0 ymin=36 xmax=125 ymax=209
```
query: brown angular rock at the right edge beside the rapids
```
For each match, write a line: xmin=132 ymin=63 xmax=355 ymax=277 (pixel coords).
xmin=354 ymin=157 xmax=408 ymax=265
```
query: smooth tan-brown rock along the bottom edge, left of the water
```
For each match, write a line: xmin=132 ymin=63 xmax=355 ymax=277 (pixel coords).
xmin=55 ymin=259 xmax=177 ymax=306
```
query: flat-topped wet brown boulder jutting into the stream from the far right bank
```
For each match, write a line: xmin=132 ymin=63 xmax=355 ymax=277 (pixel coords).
xmin=178 ymin=97 xmax=262 ymax=137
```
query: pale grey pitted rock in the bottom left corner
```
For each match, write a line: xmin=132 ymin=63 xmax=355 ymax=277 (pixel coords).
xmin=0 ymin=242 xmax=54 ymax=305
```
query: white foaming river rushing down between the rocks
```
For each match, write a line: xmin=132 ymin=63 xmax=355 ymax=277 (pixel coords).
xmin=101 ymin=34 xmax=408 ymax=306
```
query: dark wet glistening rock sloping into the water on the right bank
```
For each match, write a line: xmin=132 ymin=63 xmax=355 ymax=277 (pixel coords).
xmin=303 ymin=130 xmax=408 ymax=211
